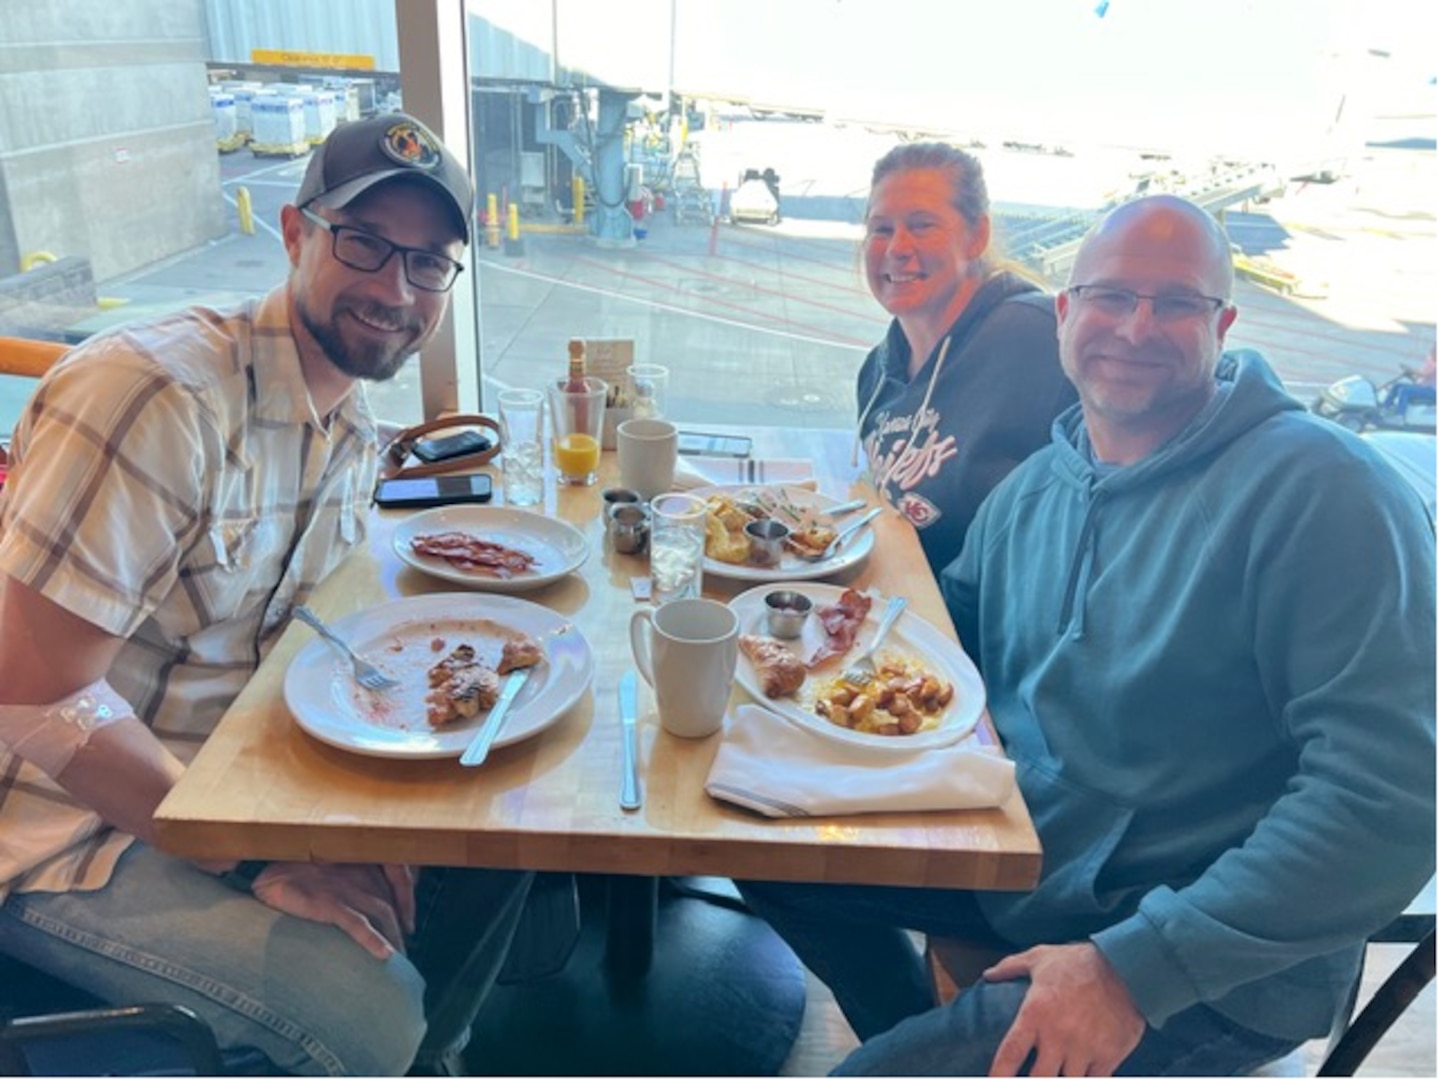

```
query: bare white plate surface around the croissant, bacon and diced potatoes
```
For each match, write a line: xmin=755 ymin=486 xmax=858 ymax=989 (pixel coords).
xmin=730 ymin=581 xmax=984 ymax=751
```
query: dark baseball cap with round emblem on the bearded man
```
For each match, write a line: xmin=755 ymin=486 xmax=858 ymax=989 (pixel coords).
xmin=295 ymin=112 xmax=475 ymax=243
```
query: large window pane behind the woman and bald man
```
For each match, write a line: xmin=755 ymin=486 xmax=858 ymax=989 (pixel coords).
xmin=469 ymin=0 xmax=1435 ymax=427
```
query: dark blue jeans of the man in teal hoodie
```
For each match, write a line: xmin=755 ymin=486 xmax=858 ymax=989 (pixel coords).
xmin=737 ymin=882 xmax=1298 ymax=1076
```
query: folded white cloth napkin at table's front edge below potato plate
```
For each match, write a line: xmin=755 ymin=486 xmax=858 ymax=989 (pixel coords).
xmin=705 ymin=705 xmax=1014 ymax=817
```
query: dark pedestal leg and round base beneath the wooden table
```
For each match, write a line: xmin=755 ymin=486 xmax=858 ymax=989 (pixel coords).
xmin=465 ymin=876 xmax=804 ymax=1076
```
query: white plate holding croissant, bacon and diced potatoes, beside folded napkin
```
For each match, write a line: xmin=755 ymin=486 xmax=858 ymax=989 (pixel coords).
xmin=730 ymin=581 xmax=984 ymax=751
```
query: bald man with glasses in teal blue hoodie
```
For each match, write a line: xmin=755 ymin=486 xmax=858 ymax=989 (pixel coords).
xmin=744 ymin=196 xmax=1435 ymax=1076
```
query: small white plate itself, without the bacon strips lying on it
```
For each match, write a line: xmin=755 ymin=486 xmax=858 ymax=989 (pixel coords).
xmin=393 ymin=503 xmax=590 ymax=592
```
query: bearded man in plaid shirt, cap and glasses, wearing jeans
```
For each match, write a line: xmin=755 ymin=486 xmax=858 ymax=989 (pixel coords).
xmin=0 ymin=114 xmax=531 ymax=1076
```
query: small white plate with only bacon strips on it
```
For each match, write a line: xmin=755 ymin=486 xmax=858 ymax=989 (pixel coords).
xmin=393 ymin=505 xmax=590 ymax=592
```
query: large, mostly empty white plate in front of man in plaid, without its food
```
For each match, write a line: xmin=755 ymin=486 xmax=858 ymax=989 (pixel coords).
xmin=285 ymin=592 xmax=594 ymax=758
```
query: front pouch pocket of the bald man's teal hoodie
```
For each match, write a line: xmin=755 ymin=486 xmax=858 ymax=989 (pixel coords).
xmin=976 ymin=761 xmax=1143 ymax=945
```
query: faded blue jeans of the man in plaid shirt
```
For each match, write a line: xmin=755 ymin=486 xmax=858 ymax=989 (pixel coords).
xmin=0 ymin=843 xmax=531 ymax=1076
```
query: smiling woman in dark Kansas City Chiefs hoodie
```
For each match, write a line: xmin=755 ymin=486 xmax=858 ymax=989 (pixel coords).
xmin=858 ymin=142 xmax=1073 ymax=571
